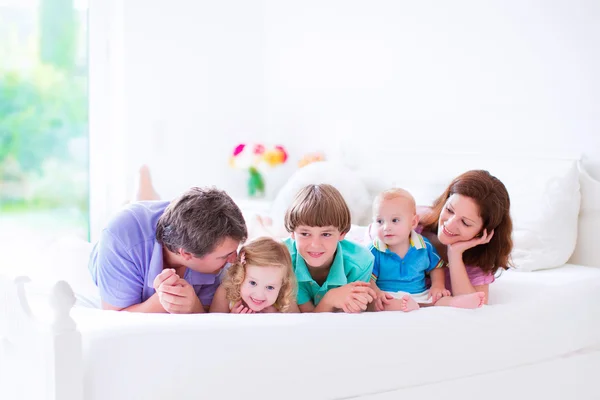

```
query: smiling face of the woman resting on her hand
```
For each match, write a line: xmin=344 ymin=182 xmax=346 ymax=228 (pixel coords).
xmin=438 ymin=194 xmax=483 ymax=246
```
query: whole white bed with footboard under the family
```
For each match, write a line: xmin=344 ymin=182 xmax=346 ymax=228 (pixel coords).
xmin=0 ymin=154 xmax=600 ymax=400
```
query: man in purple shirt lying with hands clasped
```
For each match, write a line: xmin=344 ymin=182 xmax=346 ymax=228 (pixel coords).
xmin=89 ymin=187 xmax=248 ymax=314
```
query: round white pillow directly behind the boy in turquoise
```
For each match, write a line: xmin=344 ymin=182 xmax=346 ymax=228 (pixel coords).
xmin=270 ymin=161 xmax=371 ymax=237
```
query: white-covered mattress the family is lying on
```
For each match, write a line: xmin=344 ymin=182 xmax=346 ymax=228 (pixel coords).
xmin=63 ymin=265 xmax=600 ymax=400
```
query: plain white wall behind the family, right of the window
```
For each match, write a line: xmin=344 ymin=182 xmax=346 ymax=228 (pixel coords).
xmin=91 ymin=0 xmax=600 ymax=231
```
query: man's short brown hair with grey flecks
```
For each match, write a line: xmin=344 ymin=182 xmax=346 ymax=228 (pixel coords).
xmin=156 ymin=187 xmax=248 ymax=257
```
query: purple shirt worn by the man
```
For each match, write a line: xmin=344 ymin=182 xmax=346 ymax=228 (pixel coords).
xmin=88 ymin=201 xmax=220 ymax=308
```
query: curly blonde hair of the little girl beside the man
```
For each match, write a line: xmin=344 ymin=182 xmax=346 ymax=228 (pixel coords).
xmin=222 ymin=236 xmax=296 ymax=312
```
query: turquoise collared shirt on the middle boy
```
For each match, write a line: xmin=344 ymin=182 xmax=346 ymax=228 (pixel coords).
xmin=283 ymin=238 xmax=374 ymax=306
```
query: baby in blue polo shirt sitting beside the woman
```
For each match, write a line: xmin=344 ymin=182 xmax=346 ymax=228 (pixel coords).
xmin=370 ymin=189 xmax=484 ymax=312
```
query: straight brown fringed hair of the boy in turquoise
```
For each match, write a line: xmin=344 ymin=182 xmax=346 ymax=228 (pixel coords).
xmin=285 ymin=184 xmax=351 ymax=234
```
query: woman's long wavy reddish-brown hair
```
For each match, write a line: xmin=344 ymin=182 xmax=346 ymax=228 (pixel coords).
xmin=421 ymin=170 xmax=513 ymax=274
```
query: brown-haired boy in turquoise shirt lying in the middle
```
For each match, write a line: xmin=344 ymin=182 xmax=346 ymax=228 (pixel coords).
xmin=284 ymin=184 xmax=375 ymax=313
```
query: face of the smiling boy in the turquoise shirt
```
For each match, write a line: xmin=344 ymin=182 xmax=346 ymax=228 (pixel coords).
xmin=292 ymin=225 xmax=346 ymax=268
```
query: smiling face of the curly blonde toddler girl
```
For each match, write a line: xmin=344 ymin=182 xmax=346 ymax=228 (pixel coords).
xmin=240 ymin=265 xmax=284 ymax=312
